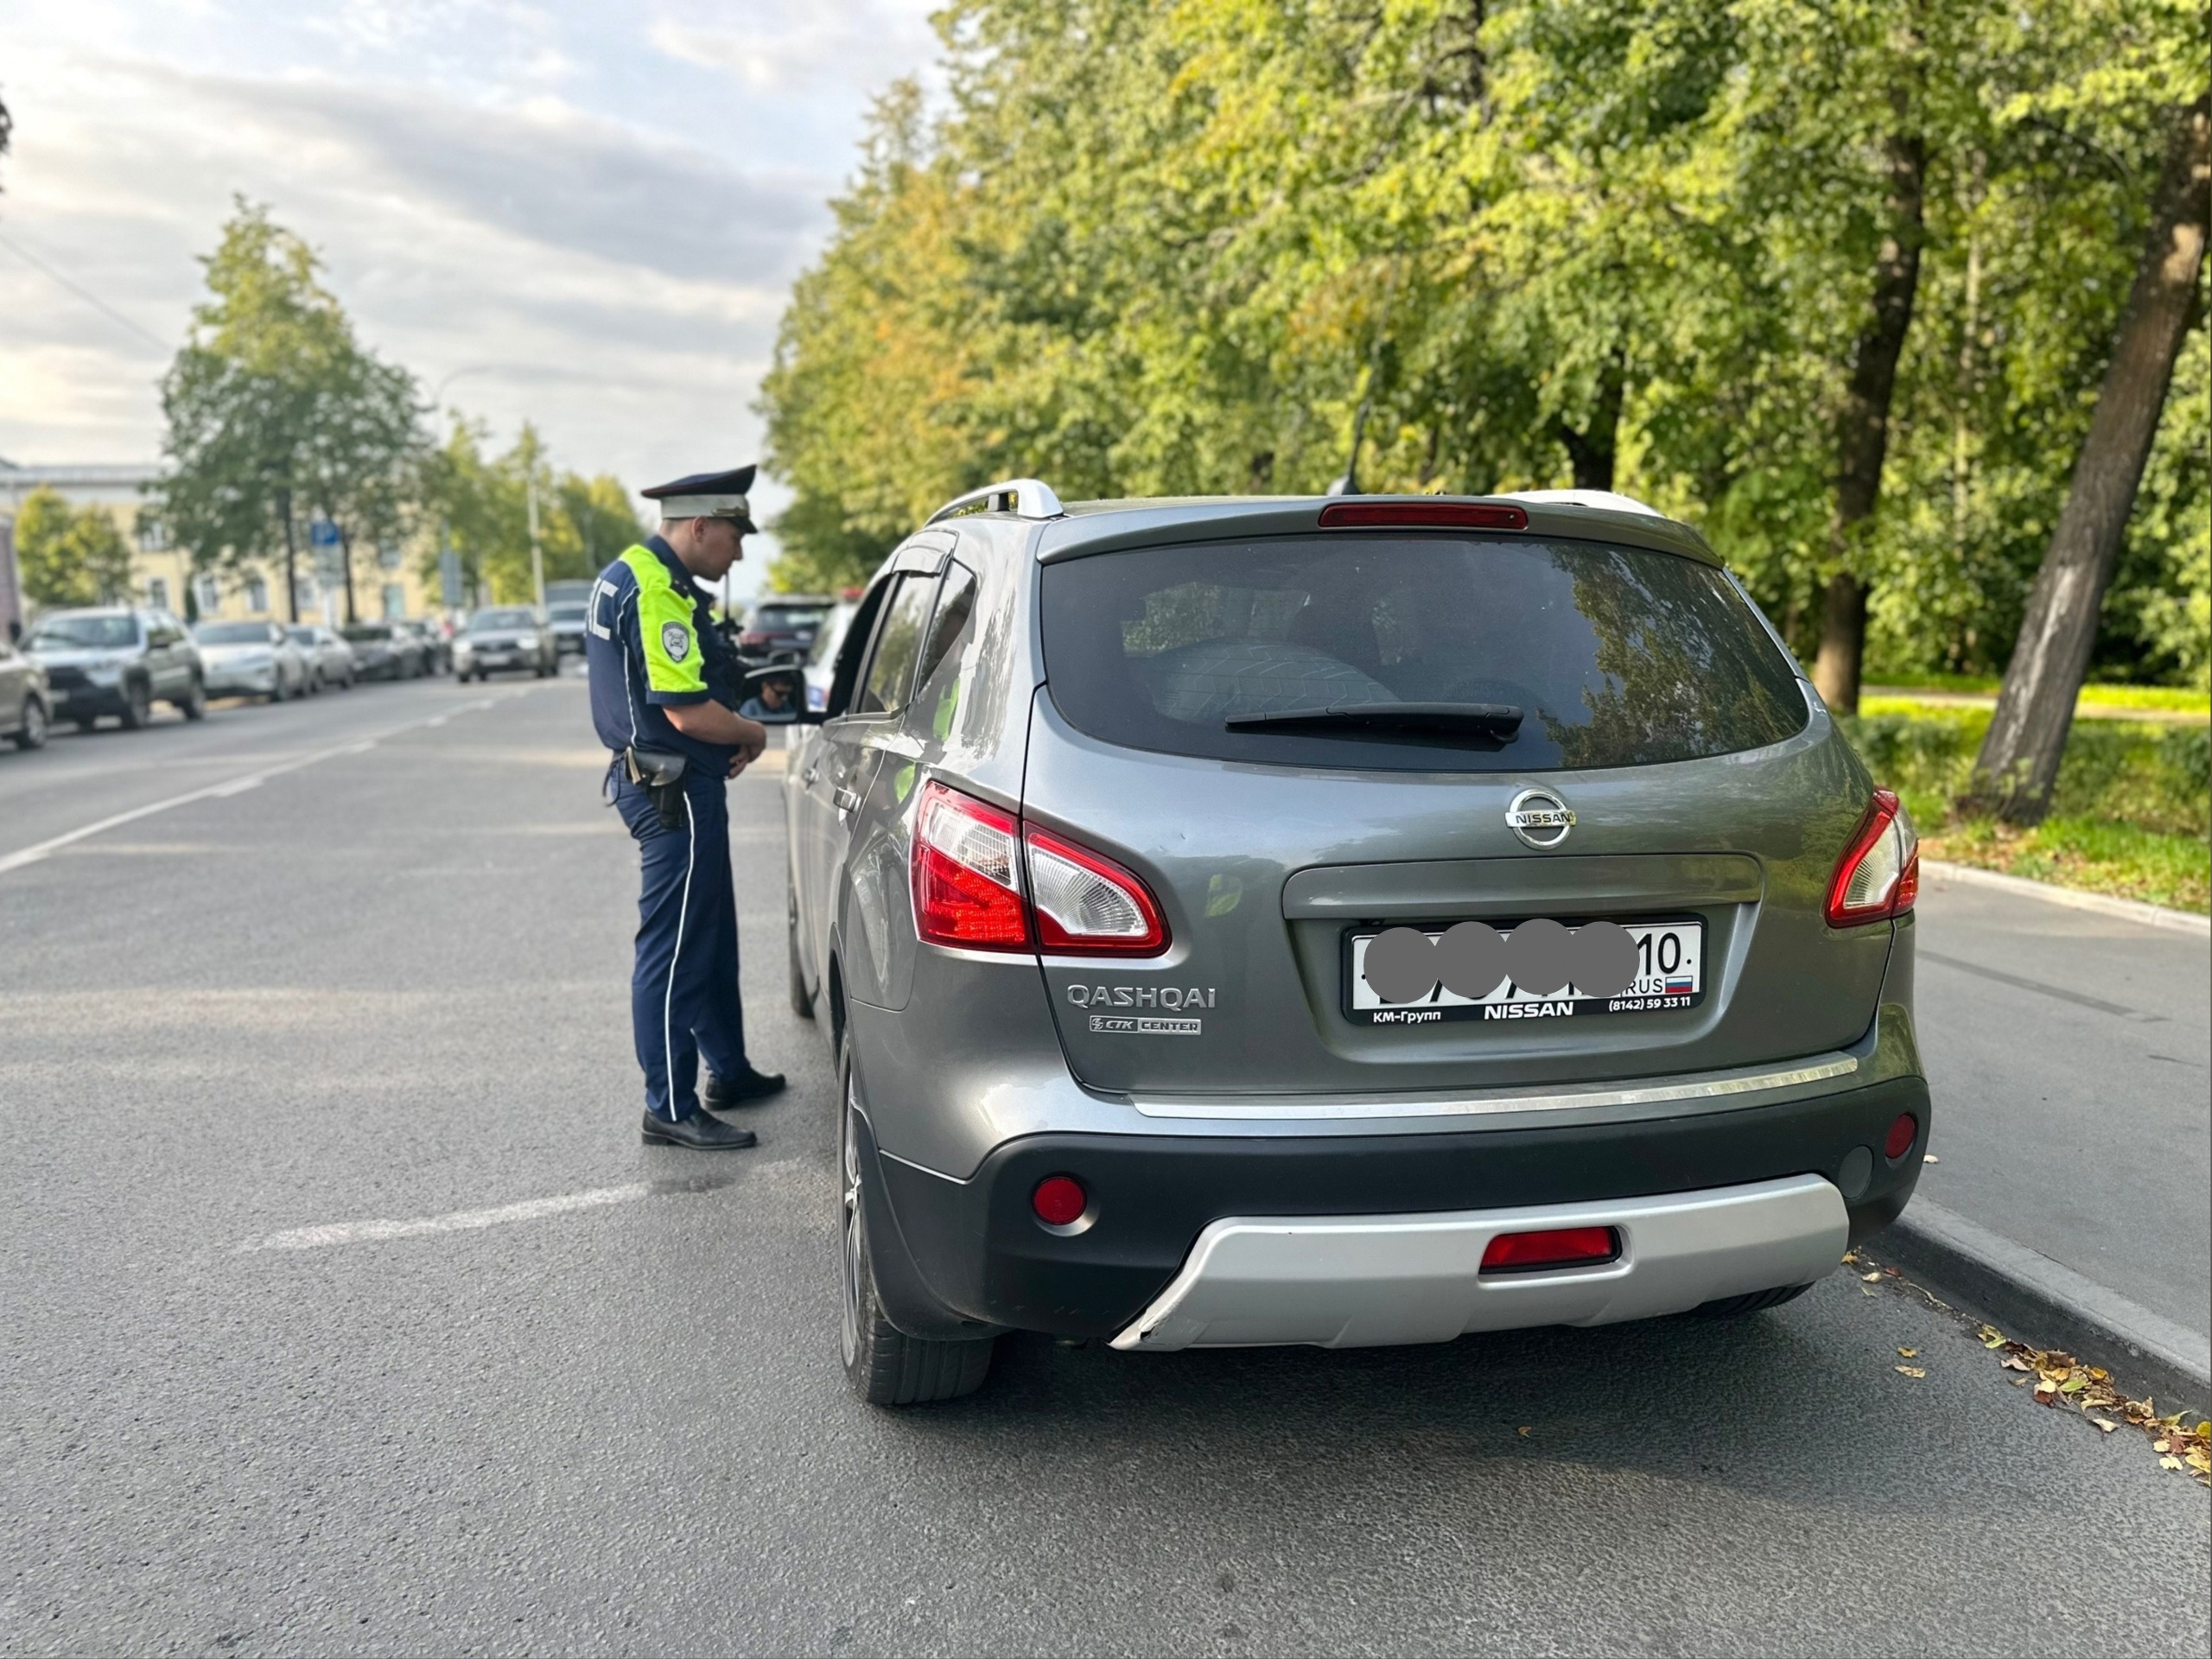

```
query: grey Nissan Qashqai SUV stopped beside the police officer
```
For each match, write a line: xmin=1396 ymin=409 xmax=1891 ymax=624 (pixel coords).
xmin=785 ymin=480 xmax=1929 ymax=1405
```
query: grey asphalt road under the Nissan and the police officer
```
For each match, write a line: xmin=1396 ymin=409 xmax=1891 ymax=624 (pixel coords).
xmin=0 ymin=681 xmax=2212 ymax=1655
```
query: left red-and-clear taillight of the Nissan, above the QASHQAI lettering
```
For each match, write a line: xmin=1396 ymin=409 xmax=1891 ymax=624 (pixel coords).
xmin=913 ymin=781 xmax=1168 ymax=956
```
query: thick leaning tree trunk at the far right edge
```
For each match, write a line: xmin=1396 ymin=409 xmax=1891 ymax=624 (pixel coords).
xmin=1968 ymin=98 xmax=2212 ymax=825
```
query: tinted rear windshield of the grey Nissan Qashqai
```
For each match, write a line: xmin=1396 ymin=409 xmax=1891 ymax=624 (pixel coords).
xmin=1044 ymin=536 xmax=1808 ymax=772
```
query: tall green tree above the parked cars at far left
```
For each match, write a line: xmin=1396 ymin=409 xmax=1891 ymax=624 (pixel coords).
xmin=159 ymin=199 xmax=427 ymax=613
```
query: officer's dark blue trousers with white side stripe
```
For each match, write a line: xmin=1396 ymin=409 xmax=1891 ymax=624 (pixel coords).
xmin=615 ymin=767 xmax=746 ymax=1122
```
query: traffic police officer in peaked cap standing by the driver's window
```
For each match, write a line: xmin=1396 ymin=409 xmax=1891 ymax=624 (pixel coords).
xmin=584 ymin=467 xmax=783 ymax=1150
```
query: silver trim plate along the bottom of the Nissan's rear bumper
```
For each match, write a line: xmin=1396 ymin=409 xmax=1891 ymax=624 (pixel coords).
xmin=1113 ymin=1174 xmax=1849 ymax=1351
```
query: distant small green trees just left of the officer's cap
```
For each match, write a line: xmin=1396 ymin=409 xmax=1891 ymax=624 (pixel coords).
xmin=423 ymin=420 xmax=651 ymax=604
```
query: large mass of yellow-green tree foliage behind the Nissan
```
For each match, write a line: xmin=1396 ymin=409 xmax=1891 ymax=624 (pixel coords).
xmin=761 ymin=0 xmax=2212 ymax=681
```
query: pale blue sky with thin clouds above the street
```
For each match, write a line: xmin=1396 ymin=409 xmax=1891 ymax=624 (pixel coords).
xmin=0 ymin=0 xmax=936 ymax=583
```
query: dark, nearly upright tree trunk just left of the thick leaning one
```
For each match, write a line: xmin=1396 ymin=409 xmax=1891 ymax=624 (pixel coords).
xmin=1812 ymin=133 xmax=1927 ymax=715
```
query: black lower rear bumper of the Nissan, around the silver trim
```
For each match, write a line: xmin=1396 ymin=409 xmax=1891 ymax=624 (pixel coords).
xmin=861 ymin=1075 xmax=1929 ymax=1347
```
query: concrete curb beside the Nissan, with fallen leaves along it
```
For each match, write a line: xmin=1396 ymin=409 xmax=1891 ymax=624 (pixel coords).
xmin=1865 ymin=1199 xmax=2212 ymax=1411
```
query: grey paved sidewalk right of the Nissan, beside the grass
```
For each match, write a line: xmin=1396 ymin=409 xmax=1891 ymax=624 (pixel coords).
xmin=1873 ymin=869 xmax=2212 ymax=1405
